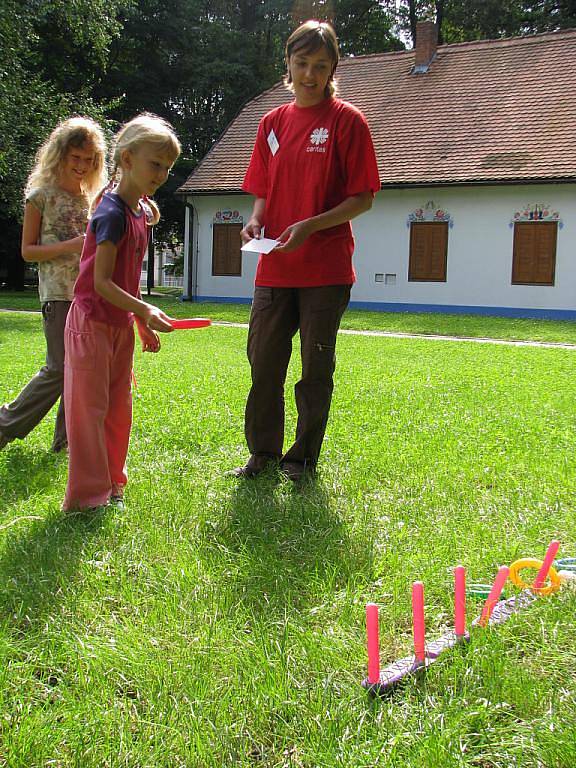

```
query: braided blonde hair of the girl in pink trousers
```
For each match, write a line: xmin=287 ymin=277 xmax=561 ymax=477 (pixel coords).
xmin=107 ymin=112 xmax=182 ymax=225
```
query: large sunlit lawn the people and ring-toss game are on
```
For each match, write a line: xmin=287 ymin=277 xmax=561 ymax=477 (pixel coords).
xmin=0 ymin=305 xmax=576 ymax=768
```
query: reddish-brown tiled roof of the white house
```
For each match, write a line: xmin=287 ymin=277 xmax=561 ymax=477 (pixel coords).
xmin=179 ymin=30 xmax=576 ymax=194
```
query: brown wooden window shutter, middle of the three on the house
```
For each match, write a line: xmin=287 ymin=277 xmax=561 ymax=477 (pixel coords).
xmin=408 ymin=221 xmax=448 ymax=283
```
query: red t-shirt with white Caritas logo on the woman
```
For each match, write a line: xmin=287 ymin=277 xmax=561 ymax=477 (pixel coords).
xmin=242 ymin=98 xmax=380 ymax=288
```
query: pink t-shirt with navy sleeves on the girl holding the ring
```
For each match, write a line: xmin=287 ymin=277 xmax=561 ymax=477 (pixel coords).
xmin=74 ymin=192 xmax=149 ymax=326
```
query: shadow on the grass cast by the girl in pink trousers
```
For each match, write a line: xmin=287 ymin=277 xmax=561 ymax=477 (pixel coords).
xmin=0 ymin=508 xmax=106 ymax=636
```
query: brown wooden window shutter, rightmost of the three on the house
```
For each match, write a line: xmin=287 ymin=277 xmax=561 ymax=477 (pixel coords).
xmin=512 ymin=221 xmax=558 ymax=285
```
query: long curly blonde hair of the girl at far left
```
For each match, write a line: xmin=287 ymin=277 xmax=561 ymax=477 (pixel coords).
xmin=24 ymin=117 xmax=107 ymax=201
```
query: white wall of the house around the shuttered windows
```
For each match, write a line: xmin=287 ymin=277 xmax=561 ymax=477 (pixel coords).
xmin=191 ymin=184 xmax=576 ymax=311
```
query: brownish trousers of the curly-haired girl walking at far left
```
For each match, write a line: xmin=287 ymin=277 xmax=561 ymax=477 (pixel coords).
xmin=0 ymin=301 xmax=71 ymax=451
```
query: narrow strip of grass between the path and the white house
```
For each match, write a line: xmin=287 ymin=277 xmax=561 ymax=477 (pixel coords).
xmin=0 ymin=289 xmax=576 ymax=344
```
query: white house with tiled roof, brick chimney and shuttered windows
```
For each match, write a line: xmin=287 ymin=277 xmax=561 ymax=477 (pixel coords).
xmin=179 ymin=22 xmax=576 ymax=319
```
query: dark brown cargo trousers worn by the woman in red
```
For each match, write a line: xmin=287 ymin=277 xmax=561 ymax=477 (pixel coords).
xmin=245 ymin=285 xmax=351 ymax=468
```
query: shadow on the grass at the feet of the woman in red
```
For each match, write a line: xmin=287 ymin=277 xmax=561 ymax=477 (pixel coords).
xmin=215 ymin=473 xmax=369 ymax=615
